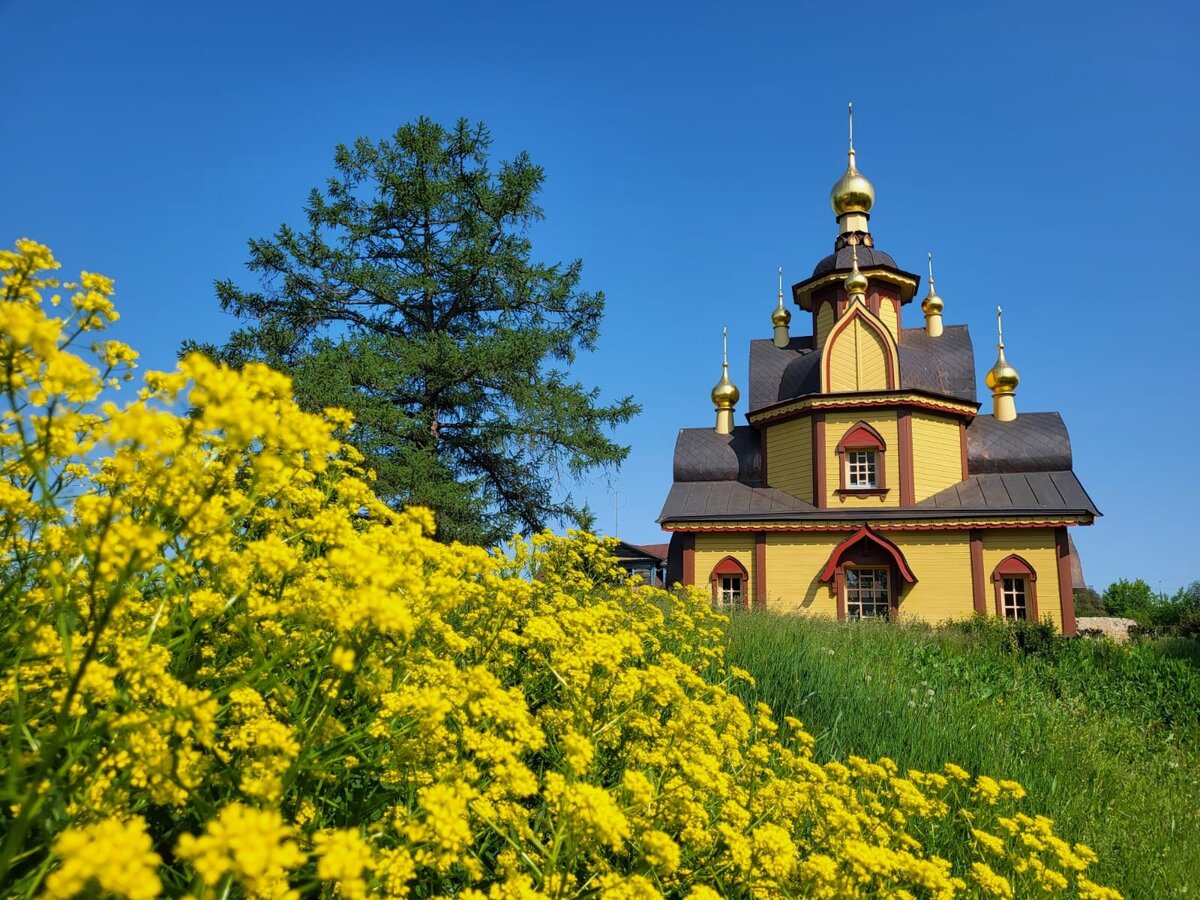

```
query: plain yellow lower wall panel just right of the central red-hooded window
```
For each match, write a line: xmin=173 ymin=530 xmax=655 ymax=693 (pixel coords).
xmin=883 ymin=532 xmax=974 ymax=625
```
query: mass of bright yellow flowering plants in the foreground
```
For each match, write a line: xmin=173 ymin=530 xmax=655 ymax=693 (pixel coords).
xmin=0 ymin=241 xmax=1117 ymax=900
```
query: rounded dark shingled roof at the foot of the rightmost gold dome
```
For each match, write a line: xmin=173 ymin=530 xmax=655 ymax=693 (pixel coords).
xmin=967 ymin=413 xmax=1072 ymax=475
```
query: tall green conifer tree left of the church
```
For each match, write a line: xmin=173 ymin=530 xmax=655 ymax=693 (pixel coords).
xmin=185 ymin=118 xmax=640 ymax=544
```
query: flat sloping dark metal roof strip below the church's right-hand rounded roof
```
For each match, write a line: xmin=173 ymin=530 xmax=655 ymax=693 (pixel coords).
xmin=913 ymin=468 xmax=1100 ymax=516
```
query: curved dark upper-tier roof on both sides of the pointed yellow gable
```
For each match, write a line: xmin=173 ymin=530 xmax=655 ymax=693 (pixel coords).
xmin=750 ymin=325 xmax=976 ymax=413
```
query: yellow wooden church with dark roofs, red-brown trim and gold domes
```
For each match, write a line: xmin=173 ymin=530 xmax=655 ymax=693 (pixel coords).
xmin=659 ymin=111 xmax=1099 ymax=635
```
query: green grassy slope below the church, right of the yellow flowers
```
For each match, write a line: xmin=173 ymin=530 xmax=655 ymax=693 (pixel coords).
xmin=730 ymin=613 xmax=1200 ymax=898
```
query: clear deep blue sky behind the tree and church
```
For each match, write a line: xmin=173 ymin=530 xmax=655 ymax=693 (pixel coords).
xmin=0 ymin=0 xmax=1200 ymax=600
